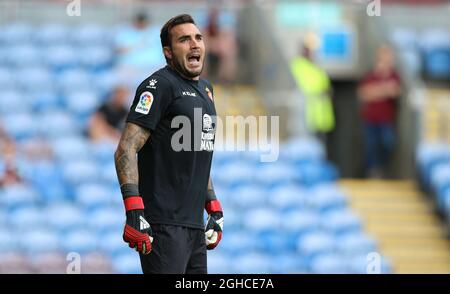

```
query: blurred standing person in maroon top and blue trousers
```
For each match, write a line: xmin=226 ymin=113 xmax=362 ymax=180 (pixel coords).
xmin=358 ymin=45 xmax=401 ymax=178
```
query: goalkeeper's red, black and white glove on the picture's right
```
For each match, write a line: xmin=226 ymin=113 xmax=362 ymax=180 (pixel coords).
xmin=205 ymin=200 xmax=223 ymax=250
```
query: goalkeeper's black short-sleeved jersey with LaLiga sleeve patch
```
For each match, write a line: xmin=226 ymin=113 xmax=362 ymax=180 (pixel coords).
xmin=127 ymin=66 xmax=216 ymax=229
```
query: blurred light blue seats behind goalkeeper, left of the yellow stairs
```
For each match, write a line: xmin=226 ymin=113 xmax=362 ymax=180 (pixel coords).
xmin=0 ymin=22 xmax=390 ymax=273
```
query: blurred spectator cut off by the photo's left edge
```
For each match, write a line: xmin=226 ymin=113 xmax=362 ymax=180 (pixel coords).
xmin=0 ymin=129 xmax=22 ymax=188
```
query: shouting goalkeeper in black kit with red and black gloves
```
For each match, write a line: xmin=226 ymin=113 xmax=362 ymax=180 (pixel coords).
xmin=114 ymin=14 xmax=223 ymax=274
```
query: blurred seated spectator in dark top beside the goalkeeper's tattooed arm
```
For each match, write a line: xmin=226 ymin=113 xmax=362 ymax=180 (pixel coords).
xmin=88 ymin=87 xmax=128 ymax=143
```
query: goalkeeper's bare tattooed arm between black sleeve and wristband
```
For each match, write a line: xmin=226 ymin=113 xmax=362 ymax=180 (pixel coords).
xmin=114 ymin=123 xmax=150 ymax=186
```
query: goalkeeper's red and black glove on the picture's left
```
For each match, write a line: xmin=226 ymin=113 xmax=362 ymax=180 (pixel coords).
xmin=123 ymin=196 xmax=153 ymax=254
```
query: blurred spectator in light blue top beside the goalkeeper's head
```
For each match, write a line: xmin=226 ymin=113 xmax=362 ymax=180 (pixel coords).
xmin=115 ymin=13 xmax=165 ymax=86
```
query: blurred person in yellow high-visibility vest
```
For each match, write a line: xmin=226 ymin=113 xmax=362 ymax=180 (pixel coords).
xmin=290 ymin=45 xmax=335 ymax=143
